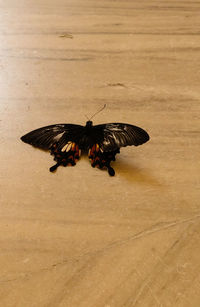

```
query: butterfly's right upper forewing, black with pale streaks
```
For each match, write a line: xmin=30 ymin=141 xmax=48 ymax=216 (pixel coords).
xmin=93 ymin=123 xmax=150 ymax=151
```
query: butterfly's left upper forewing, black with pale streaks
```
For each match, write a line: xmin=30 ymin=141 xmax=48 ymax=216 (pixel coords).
xmin=21 ymin=124 xmax=83 ymax=150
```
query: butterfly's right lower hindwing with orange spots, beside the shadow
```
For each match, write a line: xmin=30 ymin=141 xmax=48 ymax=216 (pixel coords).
xmin=88 ymin=144 xmax=119 ymax=176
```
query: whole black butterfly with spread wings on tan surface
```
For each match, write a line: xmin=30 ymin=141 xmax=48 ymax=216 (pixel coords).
xmin=21 ymin=105 xmax=149 ymax=176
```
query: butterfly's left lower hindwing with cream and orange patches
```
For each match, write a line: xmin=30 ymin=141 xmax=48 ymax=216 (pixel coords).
xmin=49 ymin=142 xmax=80 ymax=172
